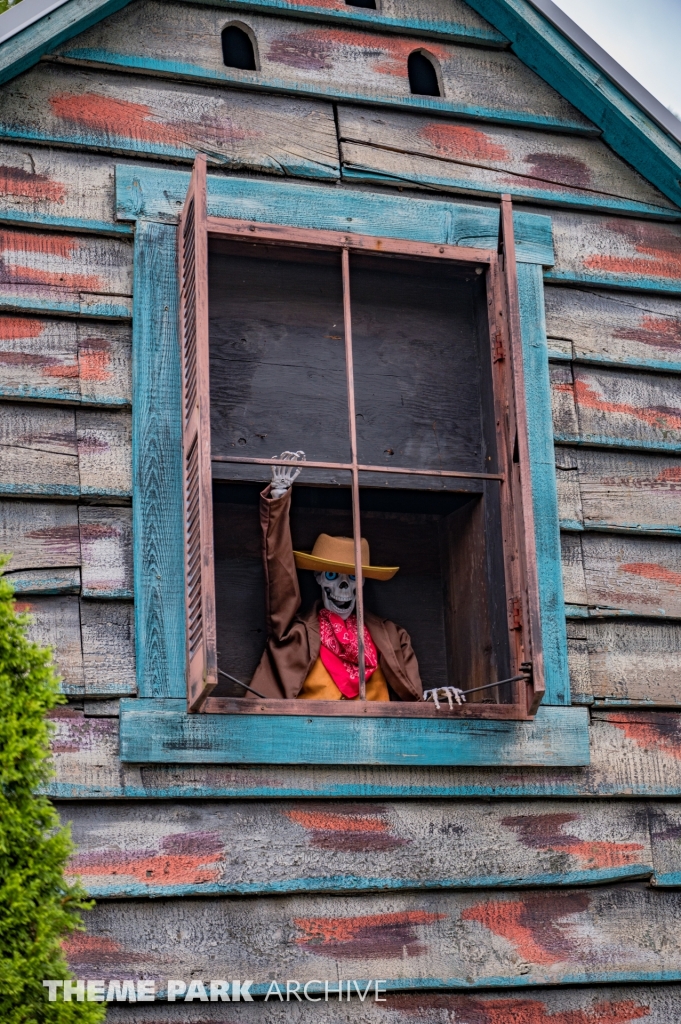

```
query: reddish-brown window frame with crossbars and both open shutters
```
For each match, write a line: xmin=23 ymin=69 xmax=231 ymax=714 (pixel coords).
xmin=178 ymin=156 xmax=545 ymax=720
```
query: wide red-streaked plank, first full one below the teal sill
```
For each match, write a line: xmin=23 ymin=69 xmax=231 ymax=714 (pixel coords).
xmin=59 ymin=801 xmax=652 ymax=899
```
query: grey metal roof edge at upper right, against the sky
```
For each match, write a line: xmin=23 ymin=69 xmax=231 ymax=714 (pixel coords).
xmin=524 ymin=0 xmax=681 ymax=143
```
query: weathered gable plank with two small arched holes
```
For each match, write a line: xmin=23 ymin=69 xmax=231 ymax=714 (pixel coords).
xmin=49 ymin=0 xmax=594 ymax=132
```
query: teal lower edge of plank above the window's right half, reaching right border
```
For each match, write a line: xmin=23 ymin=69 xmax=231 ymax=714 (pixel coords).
xmin=342 ymin=164 xmax=681 ymax=221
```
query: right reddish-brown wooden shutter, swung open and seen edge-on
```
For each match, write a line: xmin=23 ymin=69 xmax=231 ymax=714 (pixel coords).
xmin=500 ymin=196 xmax=545 ymax=715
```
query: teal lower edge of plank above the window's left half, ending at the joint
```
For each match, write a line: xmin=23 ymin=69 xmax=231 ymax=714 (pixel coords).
xmin=0 ymin=123 xmax=340 ymax=181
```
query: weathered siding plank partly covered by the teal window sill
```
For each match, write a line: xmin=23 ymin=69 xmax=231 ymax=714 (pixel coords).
xmin=39 ymin=709 xmax=681 ymax=800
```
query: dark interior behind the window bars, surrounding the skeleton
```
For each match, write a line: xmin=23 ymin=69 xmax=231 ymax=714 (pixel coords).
xmin=209 ymin=241 xmax=511 ymax=700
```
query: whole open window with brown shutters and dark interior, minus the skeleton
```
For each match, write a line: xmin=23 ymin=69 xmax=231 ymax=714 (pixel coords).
xmin=179 ymin=157 xmax=544 ymax=719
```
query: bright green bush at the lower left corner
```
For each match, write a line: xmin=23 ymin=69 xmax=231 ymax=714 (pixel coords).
xmin=0 ymin=562 xmax=105 ymax=1024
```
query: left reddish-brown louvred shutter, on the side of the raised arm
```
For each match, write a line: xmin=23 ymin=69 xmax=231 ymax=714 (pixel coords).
xmin=178 ymin=156 xmax=217 ymax=712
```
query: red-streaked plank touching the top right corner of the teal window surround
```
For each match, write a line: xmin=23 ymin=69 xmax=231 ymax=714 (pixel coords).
xmin=546 ymin=211 xmax=681 ymax=295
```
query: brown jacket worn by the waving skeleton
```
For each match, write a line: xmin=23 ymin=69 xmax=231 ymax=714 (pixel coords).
xmin=252 ymin=487 xmax=423 ymax=700
